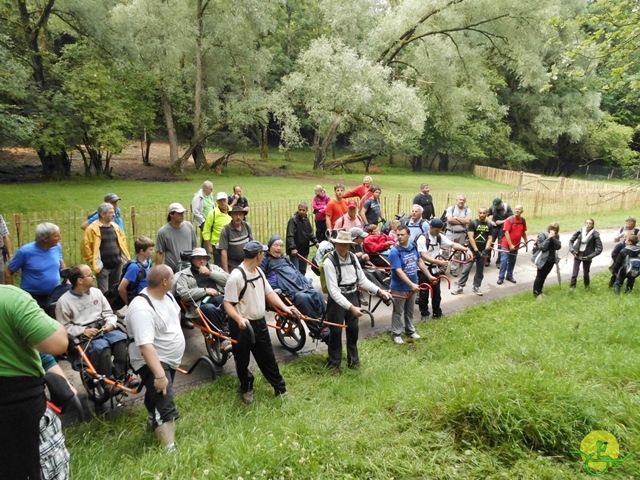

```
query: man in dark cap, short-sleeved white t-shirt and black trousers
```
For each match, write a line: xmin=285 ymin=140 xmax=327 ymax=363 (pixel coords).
xmin=224 ymin=240 xmax=295 ymax=404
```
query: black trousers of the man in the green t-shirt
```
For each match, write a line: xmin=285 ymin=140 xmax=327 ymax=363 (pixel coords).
xmin=0 ymin=377 xmax=46 ymax=480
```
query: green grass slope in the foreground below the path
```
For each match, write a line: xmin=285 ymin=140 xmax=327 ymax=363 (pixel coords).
xmin=66 ymin=275 xmax=640 ymax=480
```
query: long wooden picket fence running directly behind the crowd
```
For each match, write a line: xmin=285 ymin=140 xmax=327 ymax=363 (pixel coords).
xmin=4 ymin=189 xmax=640 ymax=265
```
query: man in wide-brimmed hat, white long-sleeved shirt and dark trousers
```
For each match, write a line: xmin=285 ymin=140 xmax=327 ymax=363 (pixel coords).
xmin=322 ymin=231 xmax=391 ymax=374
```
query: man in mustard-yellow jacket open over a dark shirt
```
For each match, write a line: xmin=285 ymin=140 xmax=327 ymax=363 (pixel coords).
xmin=80 ymin=203 xmax=131 ymax=293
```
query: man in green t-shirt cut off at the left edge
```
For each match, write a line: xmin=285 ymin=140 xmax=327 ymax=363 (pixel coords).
xmin=0 ymin=285 xmax=68 ymax=479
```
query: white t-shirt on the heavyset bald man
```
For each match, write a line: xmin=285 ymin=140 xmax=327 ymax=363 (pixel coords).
xmin=125 ymin=288 xmax=185 ymax=370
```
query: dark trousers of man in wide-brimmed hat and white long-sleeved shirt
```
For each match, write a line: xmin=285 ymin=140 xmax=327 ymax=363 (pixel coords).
xmin=327 ymin=291 xmax=360 ymax=368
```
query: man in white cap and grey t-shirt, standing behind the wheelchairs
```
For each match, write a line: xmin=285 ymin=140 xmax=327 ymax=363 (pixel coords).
xmin=155 ymin=202 xmax=198 ymax=271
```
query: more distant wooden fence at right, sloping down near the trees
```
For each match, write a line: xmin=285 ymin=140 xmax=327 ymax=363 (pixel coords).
xmin=473 ymin=165 xmax=630 ymax=192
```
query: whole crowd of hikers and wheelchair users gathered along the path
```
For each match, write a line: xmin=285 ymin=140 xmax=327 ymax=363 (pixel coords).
xmin=0 ymin=176 xmax=640 ymax=472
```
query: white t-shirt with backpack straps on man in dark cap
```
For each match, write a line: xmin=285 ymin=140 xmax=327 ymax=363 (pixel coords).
xmin=224 ymin=264 xmax=273 ymax=320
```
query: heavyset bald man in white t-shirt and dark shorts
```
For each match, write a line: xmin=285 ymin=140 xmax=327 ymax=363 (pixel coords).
xmin=125 ymin=265 xmax=185 ymax=452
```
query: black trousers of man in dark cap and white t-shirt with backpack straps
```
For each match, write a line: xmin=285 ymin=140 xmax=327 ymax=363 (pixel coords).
xmin=229 ymin=318 xmax=287 ymax=395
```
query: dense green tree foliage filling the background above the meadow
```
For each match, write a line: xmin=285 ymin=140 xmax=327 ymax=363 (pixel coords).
xmin=0 ymin=0 xmax=640 ymax=175
